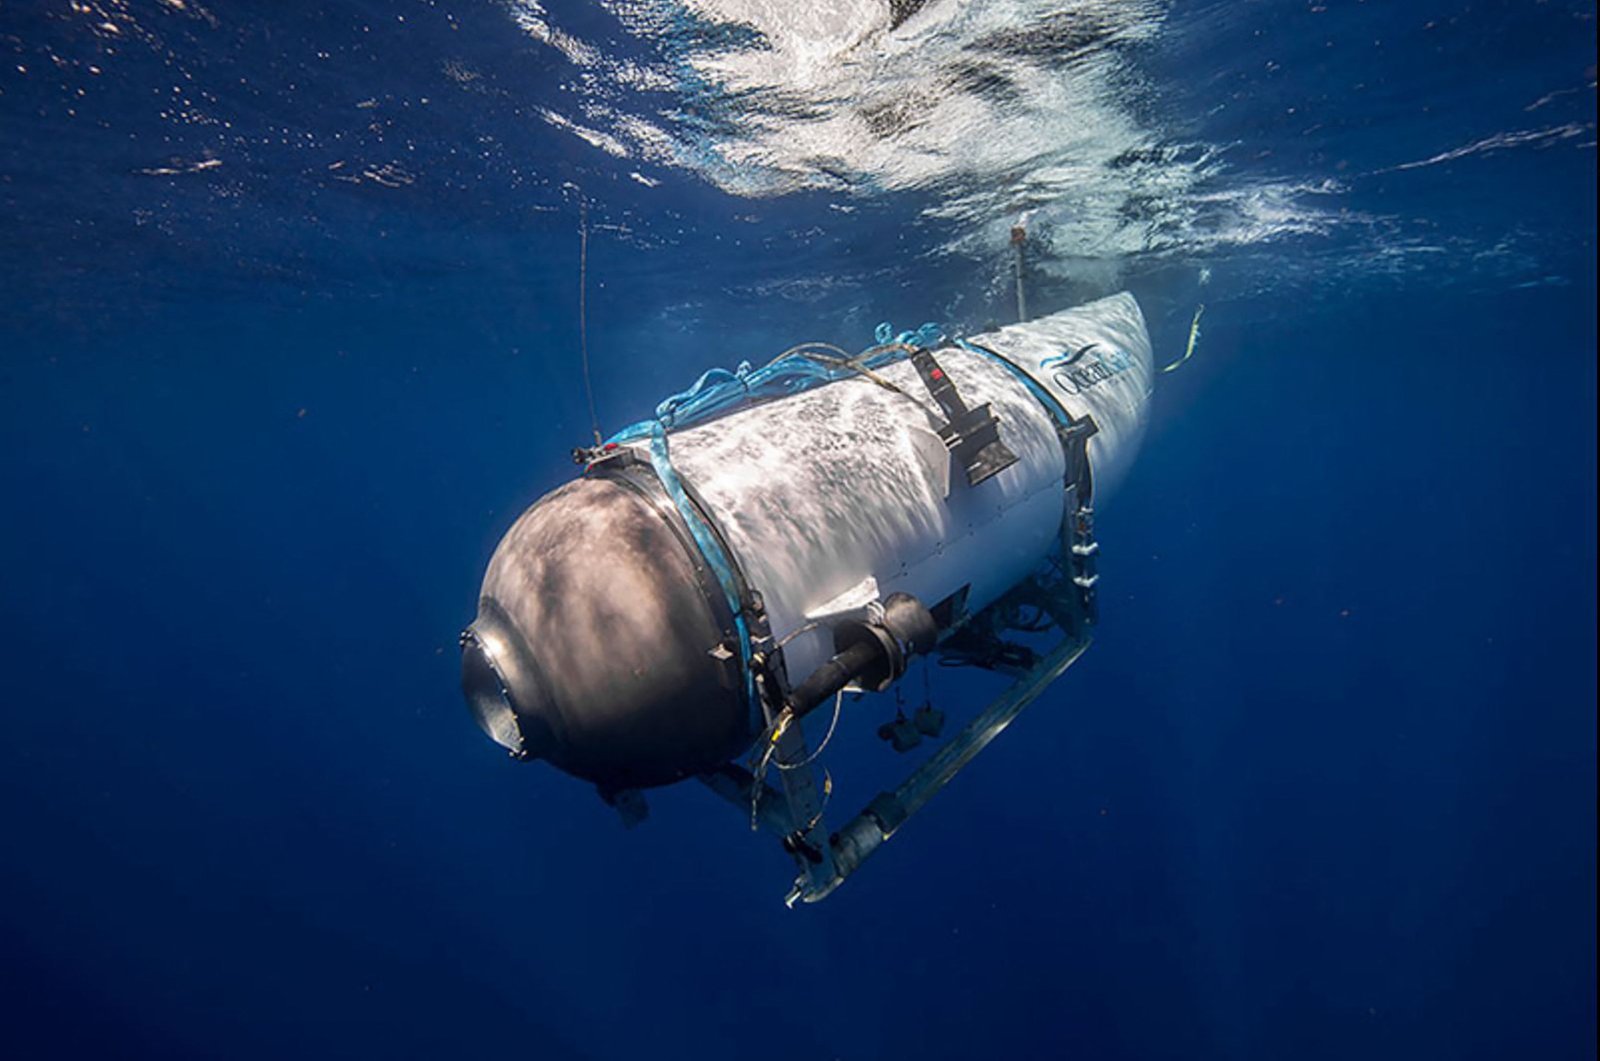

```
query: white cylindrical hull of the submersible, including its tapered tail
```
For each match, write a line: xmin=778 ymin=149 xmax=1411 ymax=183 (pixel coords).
xmin=633 ymin=293 xmax=1152 ymax=675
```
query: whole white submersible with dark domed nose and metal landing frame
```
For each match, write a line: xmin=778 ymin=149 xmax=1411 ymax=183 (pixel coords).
xmin=462 ymin=293 xmax=1152 ymax=903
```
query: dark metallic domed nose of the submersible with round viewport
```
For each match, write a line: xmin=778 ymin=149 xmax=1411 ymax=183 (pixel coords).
xmin=461 ymin=478 xmax=750 ymax=789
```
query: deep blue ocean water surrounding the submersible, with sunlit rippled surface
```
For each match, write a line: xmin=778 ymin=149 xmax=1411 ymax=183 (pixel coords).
xmin=0 ymin=0 xmax=1597 ymax=1059
